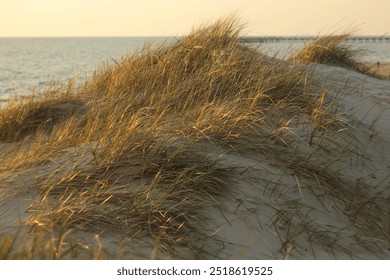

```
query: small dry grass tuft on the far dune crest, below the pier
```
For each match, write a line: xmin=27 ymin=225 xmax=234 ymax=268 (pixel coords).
xmin=289 ymin=33 xmax=369 ymax=74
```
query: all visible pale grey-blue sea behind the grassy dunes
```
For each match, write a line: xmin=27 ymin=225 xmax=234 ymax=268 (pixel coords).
xmin=0 ymin=37 xmax=390 ymax=101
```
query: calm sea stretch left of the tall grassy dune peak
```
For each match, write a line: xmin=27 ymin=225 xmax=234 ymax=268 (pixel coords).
xmin=0 ymin=37 xmax=169 ymax=98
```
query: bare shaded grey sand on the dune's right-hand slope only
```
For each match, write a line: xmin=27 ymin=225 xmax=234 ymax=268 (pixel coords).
xmin=198 ymin=61 xmax=390 ymax=259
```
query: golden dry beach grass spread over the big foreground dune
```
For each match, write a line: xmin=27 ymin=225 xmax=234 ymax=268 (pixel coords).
xmin=0 ymin=19 xmax=388 ymax=258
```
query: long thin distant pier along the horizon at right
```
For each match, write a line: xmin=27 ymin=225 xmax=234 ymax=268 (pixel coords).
xmin=240 ymin=36 xmax=390 ymax=43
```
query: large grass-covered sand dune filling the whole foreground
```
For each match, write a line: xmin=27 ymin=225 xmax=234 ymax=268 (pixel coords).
xmin=0 ymin=19 xmax=390 ymax=260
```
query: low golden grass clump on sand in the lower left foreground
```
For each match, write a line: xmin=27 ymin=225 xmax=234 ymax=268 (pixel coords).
xmin=30 ymin=140 xmax=230 ymax=256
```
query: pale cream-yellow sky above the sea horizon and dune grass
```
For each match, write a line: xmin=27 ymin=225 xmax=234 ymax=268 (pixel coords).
xmin=0 ymin=0 xmax=390 ymax=37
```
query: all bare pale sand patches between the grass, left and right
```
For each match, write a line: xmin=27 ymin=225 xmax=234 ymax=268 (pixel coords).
xmin=0 ymin=59 xmax=390 ymax=259
